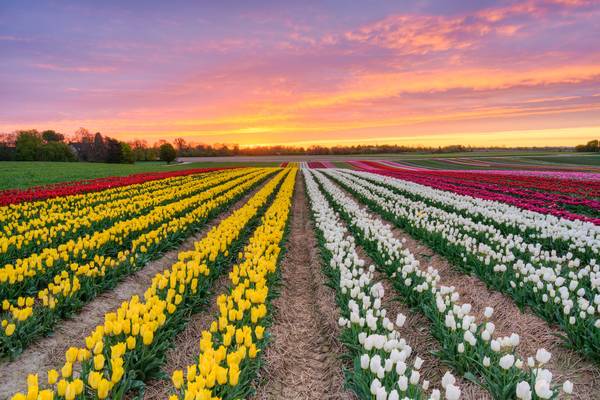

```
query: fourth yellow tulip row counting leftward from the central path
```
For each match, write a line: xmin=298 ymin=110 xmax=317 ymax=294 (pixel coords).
xmin=0 ymin=169 xmax=261 ymax=300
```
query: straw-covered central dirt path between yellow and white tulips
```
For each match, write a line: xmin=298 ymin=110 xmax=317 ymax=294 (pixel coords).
xmin=248 ymin=174 xmax=354 ymax=400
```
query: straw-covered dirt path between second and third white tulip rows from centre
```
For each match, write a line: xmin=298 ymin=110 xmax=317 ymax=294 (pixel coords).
xmin=330 ymin=177 xmax=600 ymax=400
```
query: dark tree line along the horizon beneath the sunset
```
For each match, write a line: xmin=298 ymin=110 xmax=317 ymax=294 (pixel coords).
xmin=0 ymin=128 xmax=580 ymax=163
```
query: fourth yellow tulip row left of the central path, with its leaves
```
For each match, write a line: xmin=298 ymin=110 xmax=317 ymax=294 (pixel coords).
xmin=0 ymin=170 xmax=261 ymax=300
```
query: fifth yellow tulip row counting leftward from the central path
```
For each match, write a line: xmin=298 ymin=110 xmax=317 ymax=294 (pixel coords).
xmin=0 ymin=169 xmax=251 ymax=265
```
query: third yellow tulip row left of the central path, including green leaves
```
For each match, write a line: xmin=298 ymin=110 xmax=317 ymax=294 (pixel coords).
xmin=0 ymin=170 xmax=272 ymax=358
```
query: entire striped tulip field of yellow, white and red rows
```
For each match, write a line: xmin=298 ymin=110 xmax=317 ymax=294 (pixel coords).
xmin=0 ymin=161 xmax=600 ymax=400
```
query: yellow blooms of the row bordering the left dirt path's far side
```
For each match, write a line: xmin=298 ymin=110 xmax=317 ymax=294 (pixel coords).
xmin=0 ymin=170 xmax=272 ymax=353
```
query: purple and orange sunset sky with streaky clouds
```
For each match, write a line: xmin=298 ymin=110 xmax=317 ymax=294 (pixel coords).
xmin=0 ymin=0 xmax=600 ymax=146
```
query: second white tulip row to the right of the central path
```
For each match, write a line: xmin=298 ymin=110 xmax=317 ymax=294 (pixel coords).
xmin=316 ymin=172 xmax=572 ymax=399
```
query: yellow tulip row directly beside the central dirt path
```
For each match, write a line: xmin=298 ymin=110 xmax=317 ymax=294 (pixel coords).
xmin=171 ymin=169 xmax=297 ymax=400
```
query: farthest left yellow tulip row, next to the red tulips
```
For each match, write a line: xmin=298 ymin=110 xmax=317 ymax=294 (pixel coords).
xmin=0 ymin=172 xmax=213 ymax=230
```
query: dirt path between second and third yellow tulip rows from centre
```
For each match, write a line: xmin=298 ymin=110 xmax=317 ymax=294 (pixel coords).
xmin=0 ymin=178 xmax=271 ymax=399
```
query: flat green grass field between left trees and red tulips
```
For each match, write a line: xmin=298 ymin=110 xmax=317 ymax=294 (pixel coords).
xmin=0 ymin=161 xmax=277 ymax=190
